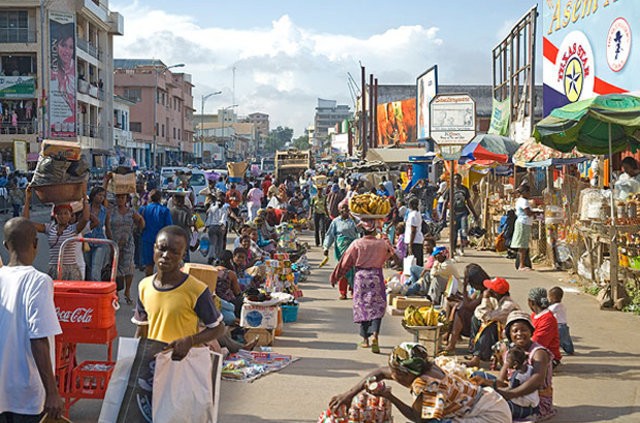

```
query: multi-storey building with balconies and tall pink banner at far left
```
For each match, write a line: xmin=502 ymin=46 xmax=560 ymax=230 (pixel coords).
xmin=0 ymin=0 xmax=124 ymax=166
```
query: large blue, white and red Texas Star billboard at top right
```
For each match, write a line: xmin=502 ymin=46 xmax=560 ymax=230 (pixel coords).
xmin=541 ymin=0 xmax=640 ymax=116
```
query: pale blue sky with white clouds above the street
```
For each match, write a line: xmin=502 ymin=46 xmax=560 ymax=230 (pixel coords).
xmin=110 ymin=0 xmax=541 ymax=136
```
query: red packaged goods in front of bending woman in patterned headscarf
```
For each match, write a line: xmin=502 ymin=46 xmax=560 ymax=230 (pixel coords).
xmin=318 ymin=392 xmax=393 ymax=423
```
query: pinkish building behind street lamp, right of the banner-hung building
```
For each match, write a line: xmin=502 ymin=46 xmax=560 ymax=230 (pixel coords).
xmin=114 ymin=59 xmax=194 ymax=168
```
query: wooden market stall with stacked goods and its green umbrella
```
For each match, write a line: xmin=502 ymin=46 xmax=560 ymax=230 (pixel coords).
xmin=534 ymin=94 xmax=640 ymax=308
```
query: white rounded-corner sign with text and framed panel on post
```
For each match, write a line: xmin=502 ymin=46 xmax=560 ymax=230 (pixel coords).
xmin=429 ymin=94 xmax=476 ymax=145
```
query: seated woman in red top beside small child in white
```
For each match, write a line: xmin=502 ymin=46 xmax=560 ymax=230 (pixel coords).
xmin=529 ymin=288 xmax=562 ymax=367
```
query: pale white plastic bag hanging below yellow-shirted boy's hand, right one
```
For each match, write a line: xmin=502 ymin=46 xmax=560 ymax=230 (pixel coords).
xmin=153 ymin=347 xmax=222 ymax=423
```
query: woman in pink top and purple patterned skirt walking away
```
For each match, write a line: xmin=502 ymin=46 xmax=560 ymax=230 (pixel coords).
xmin=330 ymin=220 xmax=395 ymax=353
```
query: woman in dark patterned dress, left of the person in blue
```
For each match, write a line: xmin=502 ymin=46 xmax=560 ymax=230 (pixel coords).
xmin=111 ymin=194 xmax=144 ymax=304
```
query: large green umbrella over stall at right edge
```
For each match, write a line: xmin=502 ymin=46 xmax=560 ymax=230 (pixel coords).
xmin=533 ymin=94 xmax=640 ymax=155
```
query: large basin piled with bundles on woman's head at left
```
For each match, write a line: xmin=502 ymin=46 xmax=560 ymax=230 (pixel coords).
xmin=31 ymin=140 xmax=89 ymax=204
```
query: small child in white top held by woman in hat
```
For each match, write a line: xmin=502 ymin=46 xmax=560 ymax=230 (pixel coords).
xmin=505 ymin=347 xmax=540 ymax=419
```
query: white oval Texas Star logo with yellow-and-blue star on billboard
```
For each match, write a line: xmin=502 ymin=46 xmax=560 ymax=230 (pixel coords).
xmin=557 ymin=31 xmax=594 ymax=103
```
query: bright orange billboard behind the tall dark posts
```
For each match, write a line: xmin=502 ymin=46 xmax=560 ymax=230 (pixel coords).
xmin=376 ymin=98 xmax=416 ymax=146
